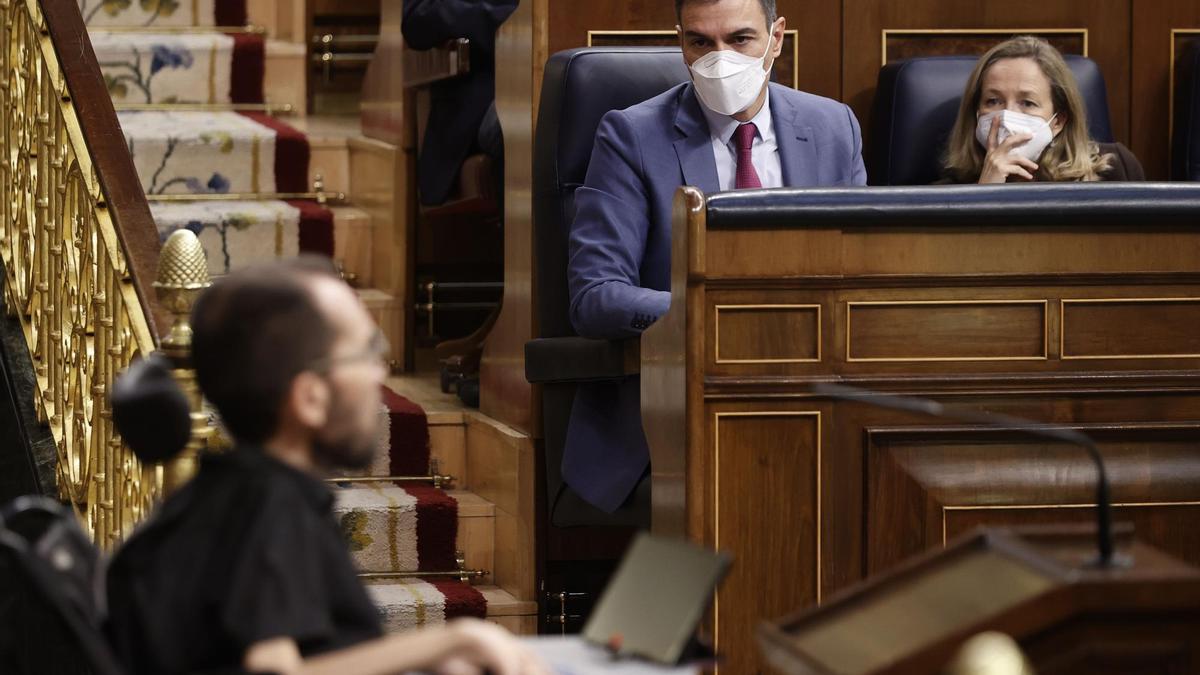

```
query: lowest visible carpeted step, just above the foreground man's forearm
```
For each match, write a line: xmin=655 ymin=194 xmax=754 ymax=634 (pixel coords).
xmin=367 ymin=579 xmax=487 ymax=633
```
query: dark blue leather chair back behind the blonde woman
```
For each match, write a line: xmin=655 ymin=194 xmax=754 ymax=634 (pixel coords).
xmin=866 ymin=55 xmax=1112 ymax=185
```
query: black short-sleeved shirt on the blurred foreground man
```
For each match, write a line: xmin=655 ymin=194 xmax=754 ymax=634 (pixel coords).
xmin=108 ymin=448 xmax=382 ymax=675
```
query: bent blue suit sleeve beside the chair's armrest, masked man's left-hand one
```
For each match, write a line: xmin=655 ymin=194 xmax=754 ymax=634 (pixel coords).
xmin=568 ymin=110 xmax=671 ymax=339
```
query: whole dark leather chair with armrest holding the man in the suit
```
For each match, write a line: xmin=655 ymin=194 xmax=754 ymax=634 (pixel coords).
xmin=526 ymin=47 xmax=689 ymax=526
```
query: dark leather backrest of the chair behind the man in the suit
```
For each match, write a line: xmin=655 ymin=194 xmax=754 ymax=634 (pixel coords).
xmin=533 ymin=47 xmax=690 ymax=338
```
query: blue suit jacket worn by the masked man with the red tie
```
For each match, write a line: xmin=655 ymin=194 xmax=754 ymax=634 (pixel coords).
xmin=563 ymin=83 xmax=866 ymax=512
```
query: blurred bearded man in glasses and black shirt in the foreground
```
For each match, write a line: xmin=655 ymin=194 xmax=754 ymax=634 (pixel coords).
xmin=108 ymin=253 xmax=541 ymax=675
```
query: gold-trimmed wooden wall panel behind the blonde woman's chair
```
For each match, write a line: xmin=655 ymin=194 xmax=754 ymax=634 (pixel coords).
xmin=842 ymin=0 xmax=1128 ymax=148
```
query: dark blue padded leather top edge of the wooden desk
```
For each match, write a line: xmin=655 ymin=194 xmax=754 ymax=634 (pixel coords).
xmin=706 ymin=183 xmax=1200 ymax=229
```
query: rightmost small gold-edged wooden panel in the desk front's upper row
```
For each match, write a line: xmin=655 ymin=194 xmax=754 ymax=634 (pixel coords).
xmin=1062 ymin=298 xmax=1200 ymax=359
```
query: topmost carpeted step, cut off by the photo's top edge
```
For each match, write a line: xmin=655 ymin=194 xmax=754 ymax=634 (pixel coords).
xmin=79 ymin=0 xmax=246 ymax=28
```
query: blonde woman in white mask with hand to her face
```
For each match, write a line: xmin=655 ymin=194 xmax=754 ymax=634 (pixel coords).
xmin=942 ymin=36 xmax=1146 ymax=183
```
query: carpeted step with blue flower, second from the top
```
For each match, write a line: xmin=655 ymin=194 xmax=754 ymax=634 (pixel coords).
xmin=89 ymin=29 xmax=266 ymax=103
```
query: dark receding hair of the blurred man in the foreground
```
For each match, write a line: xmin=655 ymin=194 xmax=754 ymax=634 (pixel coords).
xmin=192 ymin=256 xmax=337 ymax=443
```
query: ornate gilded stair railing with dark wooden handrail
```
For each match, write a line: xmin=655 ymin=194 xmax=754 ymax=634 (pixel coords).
xmin=0 ymin=0 xmax=162 ymax=548
